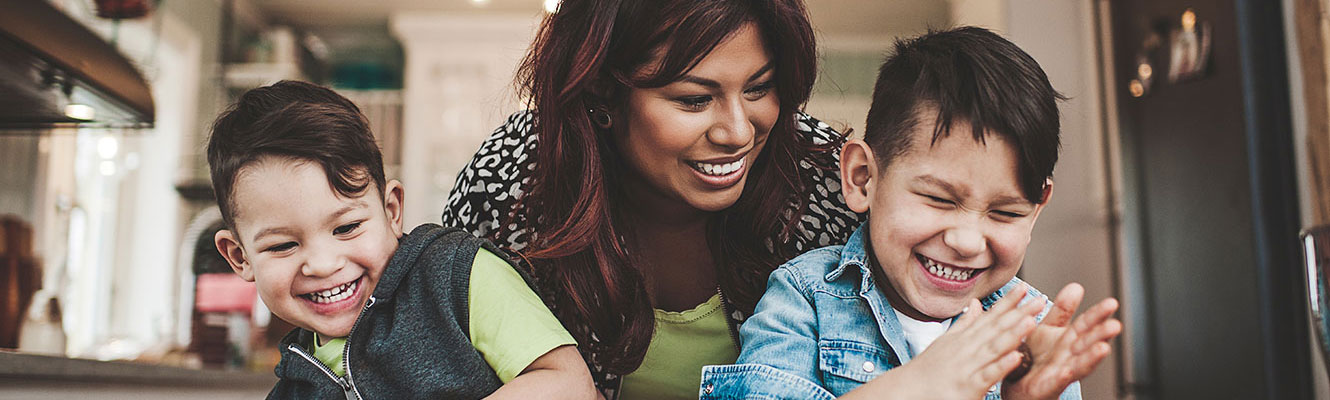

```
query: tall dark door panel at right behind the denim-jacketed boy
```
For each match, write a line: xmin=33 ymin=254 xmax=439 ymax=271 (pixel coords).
xmin=1112 ymin=0 xmax=1310 ymax=399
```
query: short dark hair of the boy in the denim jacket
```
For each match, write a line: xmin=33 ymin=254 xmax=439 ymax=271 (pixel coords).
xmin=865 ymin=27 xmax=1065 ymax=203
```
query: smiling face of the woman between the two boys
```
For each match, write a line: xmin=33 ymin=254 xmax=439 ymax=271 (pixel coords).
xmin=613 ymin=23 xmax=781 ymax=213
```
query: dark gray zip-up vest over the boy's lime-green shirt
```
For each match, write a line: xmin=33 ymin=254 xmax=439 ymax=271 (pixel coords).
xmin=267 ymin=223 xmax=508 ymax=400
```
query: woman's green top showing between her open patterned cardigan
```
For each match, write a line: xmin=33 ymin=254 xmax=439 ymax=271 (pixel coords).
xmin=620 ymin=294 xmax=739 ymax=400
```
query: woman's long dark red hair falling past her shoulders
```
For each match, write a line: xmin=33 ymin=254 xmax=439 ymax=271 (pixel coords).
xmin=508 ymin=0 xmax=818 ymax=373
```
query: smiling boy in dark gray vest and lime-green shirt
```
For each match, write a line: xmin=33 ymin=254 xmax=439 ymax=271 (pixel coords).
xmin=207 ymin=81 xmax=596 ymax=399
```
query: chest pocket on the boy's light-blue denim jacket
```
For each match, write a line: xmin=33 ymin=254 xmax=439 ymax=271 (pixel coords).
xmin=818 ymin=339 xmax=894 ymax=396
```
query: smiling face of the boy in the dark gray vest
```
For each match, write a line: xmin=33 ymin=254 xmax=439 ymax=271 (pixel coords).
xmin=215 ymin=157 xmax=402 ymax=338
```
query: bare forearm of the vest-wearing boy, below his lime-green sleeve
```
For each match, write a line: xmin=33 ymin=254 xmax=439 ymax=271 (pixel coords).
xmin=485 ymin=344 xmax=600 ymax=400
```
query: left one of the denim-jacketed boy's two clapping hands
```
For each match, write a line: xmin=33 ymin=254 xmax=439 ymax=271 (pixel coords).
xmin=899 ymin=284 xmax=1044 ymax=399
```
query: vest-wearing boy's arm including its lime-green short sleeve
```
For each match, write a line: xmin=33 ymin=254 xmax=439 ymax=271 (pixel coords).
xmin=467 ymin=249 xmax=597 ymax=399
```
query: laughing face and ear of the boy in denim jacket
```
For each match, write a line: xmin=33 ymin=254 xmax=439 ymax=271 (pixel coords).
xmin=841 ymin=114 xmax=1052 ymax=320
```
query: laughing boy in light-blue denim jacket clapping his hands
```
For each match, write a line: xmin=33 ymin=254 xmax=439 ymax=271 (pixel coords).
xmin=701 ymin=28 xmax=1121 ymax=399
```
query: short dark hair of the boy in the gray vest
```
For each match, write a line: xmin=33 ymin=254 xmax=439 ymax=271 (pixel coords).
xmin=207 ymin=81 xmax=384 ymax=230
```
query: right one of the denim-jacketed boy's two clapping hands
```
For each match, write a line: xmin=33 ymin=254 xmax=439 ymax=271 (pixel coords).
xmin=1003 ymin=283 xmax=1123 ymax=400
